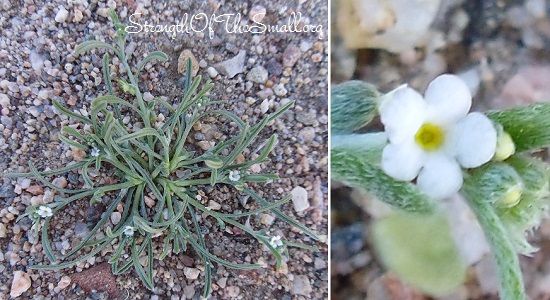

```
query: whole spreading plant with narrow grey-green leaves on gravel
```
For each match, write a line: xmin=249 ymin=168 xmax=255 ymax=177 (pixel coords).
xmin=7 ymin=11 xmax=319 ymax=297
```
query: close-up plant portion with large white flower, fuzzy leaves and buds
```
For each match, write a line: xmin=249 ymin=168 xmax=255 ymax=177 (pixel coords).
xmin=331 ymin=74 xmax=550 ymax=300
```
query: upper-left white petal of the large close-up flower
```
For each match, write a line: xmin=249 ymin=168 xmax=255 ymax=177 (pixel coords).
xmin=380 ymin=87 xmax=426 ymax=144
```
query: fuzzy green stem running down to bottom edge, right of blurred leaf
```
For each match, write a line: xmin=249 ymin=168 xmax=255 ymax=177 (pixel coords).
xmin=462 ymin=185 xmax=527 ymax=300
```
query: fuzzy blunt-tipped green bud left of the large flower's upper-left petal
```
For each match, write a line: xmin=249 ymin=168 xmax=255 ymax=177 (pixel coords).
xmin=330 ymin=80 xmax=381 ymax=134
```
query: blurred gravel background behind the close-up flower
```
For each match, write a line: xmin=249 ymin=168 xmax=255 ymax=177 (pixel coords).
xmin=331 ymin=0 xmax=550 ymax=300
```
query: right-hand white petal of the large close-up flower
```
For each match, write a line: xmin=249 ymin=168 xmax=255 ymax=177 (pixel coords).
xmin=451 ymin=112 xmax=497 ymax=168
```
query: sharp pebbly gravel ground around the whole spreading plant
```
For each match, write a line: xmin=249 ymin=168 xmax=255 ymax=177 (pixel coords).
xmin=0 ymin=0 xmax=328 ymax=299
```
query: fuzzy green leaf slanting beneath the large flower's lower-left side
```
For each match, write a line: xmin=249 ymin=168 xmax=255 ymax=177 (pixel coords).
xmin=331 ymin=148 xmax=435 ymax=214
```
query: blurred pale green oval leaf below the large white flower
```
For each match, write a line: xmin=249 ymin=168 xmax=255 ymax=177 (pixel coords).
xmin=373 ymin=214 xmax=466 ymax=295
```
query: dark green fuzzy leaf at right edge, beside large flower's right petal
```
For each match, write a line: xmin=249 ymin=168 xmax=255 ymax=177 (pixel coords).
xmin=487 ymin=103 xmax=550 ymax=152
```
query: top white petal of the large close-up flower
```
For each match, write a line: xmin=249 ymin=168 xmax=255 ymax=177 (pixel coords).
xmin=425 ymin=74 xmax=472 ymax=125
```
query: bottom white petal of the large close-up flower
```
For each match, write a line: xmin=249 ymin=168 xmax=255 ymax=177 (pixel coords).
xmin=416 ymin=154 xmax=463 ymax=199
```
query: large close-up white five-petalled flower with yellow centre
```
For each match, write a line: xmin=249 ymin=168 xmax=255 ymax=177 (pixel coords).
xmin=380 ymin=74 xmax=497 ymax=199
